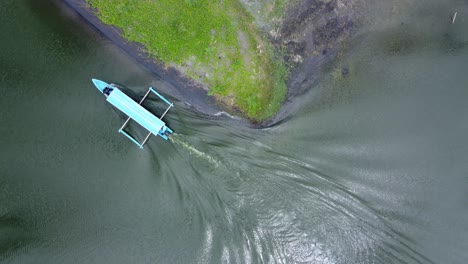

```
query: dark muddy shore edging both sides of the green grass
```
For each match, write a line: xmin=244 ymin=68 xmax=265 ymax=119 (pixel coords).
xmin=63 ymin=0 xmax=360 ymax=128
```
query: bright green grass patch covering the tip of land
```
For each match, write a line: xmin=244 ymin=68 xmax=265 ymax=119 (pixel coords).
xmin=87 ymin=0 xmax=288 ymax=121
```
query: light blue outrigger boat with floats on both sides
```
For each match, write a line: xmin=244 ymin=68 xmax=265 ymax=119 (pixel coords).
xmin=92 ymin=79 xmax=174 ymax=149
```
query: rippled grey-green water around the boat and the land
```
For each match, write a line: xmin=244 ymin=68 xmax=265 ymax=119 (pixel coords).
xmin=0 ymin=0 xmax=468 ymax=264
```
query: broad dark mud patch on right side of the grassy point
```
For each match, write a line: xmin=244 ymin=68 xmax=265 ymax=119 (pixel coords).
xmin=259 ymin=0 xmax=365 ymax=127
